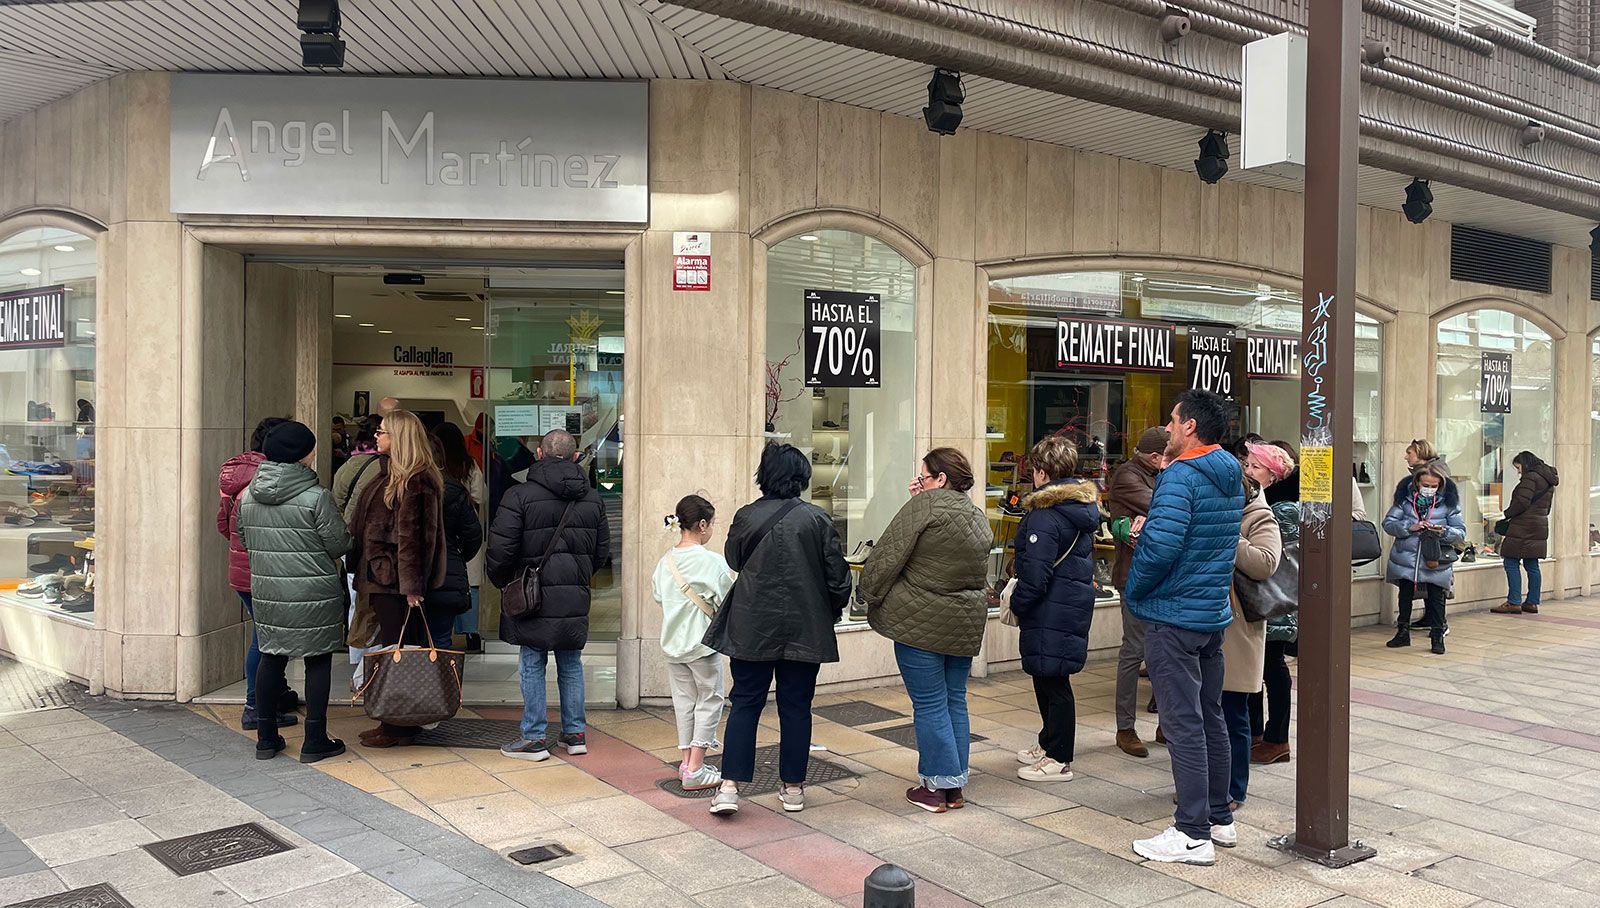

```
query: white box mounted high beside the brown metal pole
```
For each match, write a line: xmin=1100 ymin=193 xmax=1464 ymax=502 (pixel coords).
xmin=1240 ymin=34 xmax=1306 ymax=176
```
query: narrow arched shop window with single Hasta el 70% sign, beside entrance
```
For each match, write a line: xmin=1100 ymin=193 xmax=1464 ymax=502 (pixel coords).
xmin=765 ymin=230 xmax=920 ymax=619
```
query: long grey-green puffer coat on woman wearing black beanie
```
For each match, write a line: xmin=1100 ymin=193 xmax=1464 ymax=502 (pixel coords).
xmin=238 ymin=462 xmax=350 ymax=659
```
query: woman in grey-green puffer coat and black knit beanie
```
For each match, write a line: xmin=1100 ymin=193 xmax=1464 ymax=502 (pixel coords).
xmin=238 ymin=422 xmax=350 ymax=763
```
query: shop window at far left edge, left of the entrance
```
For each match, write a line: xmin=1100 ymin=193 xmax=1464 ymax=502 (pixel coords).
xmin=0 ymin=227 xmax=96 ymax=622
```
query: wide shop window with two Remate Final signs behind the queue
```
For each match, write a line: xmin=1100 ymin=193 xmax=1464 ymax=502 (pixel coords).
xmin=984 ymin=272 xmax=1386 ymax=599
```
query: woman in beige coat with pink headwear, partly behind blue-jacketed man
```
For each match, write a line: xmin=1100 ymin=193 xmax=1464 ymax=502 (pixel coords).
xmin=1222 ymin=476 xmax=1283 ymax=809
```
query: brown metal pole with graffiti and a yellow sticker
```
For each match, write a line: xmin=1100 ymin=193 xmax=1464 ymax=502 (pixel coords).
xmin=1274 ymin=0 xmax=1376 ymax=866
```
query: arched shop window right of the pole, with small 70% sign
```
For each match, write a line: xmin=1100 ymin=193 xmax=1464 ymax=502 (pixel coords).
xmin=1432 ymin=309 xmax=1555 ymax=555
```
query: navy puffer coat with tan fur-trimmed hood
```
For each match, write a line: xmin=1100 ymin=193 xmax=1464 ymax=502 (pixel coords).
xmin=1011 ymin=480 xmax=1099 ymax=678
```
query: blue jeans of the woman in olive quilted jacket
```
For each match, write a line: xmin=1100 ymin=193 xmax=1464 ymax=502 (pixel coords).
xmin=894 ymin=643 xmax=973 ymax=790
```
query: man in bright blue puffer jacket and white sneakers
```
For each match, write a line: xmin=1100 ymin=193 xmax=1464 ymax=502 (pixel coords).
xmin=1123 ymin=390 xmax=1245 ymax=865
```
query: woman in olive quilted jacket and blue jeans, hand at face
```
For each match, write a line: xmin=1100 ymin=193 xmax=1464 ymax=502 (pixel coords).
xmin=856 ymin=448 xmax=994 ymax=814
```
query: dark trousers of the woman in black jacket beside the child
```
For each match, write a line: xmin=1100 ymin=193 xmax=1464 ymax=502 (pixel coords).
xmin=722 ymin=659 xmax=822 ymax=785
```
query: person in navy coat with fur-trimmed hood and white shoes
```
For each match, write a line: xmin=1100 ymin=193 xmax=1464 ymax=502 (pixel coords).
xmin=1011 ymin=435 xmax=1099 ymax=782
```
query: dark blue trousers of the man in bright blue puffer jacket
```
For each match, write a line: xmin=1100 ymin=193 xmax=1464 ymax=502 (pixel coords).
xmin=1144 ymin=622 xmax=1234 ymax=841
